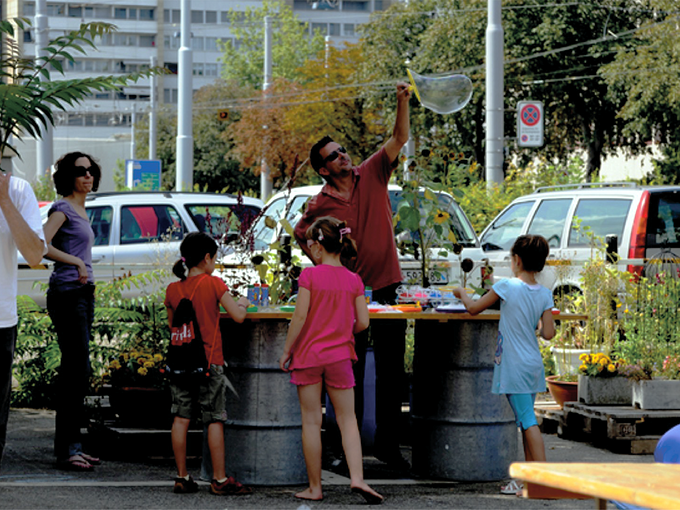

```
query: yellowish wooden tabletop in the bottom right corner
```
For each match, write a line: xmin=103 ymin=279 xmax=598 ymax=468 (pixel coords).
xmin=510 ymin=462 xmax=680 ymax=510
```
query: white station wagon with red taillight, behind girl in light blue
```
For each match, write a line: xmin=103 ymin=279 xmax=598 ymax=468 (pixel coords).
xmin=480 ymin=183 xmax=680 ymax=294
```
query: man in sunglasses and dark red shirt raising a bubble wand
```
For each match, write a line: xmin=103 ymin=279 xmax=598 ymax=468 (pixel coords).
xmin=295 ymin=83 xmax=411 ymax=470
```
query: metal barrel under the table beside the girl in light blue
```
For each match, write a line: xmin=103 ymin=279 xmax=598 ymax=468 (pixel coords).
xmin=411 ymin=319 xmax=519 ymax=481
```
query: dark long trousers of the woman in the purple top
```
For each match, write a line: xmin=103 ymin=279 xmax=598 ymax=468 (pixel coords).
xmin=47 ymin=284 xmax=94 ymax=460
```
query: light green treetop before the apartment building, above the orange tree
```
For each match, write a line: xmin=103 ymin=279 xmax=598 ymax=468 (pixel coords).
xmin=222 ymin=0 xmax=324 ymax=89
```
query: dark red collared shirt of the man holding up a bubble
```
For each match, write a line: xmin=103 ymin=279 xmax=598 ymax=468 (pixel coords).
xmin=295 ymin=148 xmax=402 ymax=290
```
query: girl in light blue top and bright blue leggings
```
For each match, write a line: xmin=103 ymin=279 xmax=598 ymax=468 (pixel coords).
xmin=453 ymin=235 xmax=555 ymax=494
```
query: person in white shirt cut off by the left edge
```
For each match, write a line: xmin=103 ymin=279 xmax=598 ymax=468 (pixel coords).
xmin=0 ymin=171 xmax=47 ymax=462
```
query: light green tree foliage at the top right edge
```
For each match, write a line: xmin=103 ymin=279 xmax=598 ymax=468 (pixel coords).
xmin=600 ymin=0 xmax=680 ymax=180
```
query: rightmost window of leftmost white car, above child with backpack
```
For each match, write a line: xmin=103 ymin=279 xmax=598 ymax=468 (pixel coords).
xmin=186 ymin=204 xmax=260 ymax=237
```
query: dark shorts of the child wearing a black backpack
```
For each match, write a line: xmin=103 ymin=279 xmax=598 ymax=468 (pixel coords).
xmin=170 ymin=365 xmax=227 ymax=424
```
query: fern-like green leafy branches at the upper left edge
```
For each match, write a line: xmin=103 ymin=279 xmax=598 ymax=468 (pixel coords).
xmin=0 ymin=18 xmax=162 ymax=159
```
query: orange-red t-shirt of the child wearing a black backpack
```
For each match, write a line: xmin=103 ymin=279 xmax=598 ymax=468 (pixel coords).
xmin=165 ymin=275 xmax=229 ymax=366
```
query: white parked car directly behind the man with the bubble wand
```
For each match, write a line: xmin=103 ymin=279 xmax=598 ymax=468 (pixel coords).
xmin=222 ymin=185 xmax=482 ymax=285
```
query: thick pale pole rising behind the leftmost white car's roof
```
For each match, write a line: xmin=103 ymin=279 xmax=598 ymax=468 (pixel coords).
xmin=175 ymin=0 xmax=194 ymax=191
